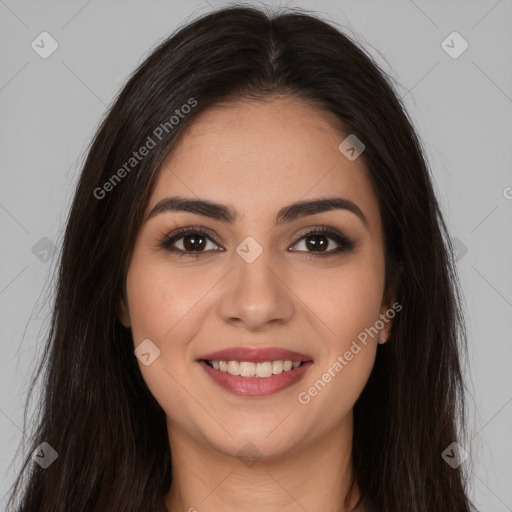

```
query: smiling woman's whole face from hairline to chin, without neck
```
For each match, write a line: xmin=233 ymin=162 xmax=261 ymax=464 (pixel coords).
xmin=121 ymin=98 xmax=389 ymax=457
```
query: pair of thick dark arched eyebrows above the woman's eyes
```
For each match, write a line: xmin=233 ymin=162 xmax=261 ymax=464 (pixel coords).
xmin=146 ymin=196 xmax=368 ymax=228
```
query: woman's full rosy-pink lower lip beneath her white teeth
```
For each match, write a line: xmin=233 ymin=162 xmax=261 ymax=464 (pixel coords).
xmin=199 ymin=361 xmax=313 ymax=397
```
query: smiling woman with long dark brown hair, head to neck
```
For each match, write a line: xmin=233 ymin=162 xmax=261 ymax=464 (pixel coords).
xmin=10 ymin=7 xmax=473 ymax=512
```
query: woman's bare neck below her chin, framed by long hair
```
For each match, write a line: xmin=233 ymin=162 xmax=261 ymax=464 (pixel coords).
xmin=165 ymin=417 xmax=359 ymax=512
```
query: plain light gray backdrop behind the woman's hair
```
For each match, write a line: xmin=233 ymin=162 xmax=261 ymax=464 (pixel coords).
xmin=0 ymin=0 xmax=512 ymax=512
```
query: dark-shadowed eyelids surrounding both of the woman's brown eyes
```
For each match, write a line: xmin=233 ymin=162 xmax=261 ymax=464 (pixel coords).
xmin=159 ymin=225 xmax=356 ymax=257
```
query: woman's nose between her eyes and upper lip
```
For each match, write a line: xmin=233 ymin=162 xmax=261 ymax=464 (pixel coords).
xmin=218 ymin=244 xmax=297 ymax=331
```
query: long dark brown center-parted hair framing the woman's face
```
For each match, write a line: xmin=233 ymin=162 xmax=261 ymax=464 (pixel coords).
xmin=9 ymin=7 xmax=478 ymax=512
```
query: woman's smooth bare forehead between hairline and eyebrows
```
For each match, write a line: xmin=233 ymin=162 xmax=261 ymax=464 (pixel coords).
xmin=148 ymin=97 xmax=380 ymax=235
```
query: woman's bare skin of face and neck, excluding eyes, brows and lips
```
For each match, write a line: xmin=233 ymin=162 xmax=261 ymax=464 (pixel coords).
xmin=121 ymin=97 xmax=391 ymax=512
